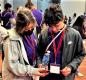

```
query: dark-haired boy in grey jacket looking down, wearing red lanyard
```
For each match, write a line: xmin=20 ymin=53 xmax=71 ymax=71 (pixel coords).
xmin=37 ymin=4 xmax=85 ymax=80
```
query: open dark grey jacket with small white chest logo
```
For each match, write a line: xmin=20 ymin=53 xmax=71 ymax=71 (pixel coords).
xmin=38 ymin=27 xmax=85 ymax=80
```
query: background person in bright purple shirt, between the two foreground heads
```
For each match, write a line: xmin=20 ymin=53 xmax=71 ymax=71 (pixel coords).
xmin=25 ymin=1 xmax=43 ymax=38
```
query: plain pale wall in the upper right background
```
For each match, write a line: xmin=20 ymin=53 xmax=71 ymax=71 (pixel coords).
xmin=61 ymin=0 xmax=85 ymax=17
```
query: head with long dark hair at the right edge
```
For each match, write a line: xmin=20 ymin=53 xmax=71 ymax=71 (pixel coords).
xmin=73 ymin=15 xmax=86 ymax=39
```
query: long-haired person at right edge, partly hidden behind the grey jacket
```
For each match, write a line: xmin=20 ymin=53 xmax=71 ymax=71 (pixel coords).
xmin=73 ymin=15 xmax=86 ymax=76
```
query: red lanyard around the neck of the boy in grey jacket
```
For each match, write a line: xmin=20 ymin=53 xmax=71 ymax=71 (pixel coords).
xmin=52 ymin=31 xmax=64 ymax=64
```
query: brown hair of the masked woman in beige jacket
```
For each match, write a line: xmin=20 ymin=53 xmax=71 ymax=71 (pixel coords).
xmin=16 ymin=8 xmax=36 ymax=33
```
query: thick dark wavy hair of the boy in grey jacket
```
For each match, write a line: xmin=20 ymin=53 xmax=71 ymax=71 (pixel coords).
xmin=44 ymin=4 xmax=63 ymax=25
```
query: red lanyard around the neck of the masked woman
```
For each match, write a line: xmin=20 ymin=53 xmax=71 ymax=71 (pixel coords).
xmin=24 ymin=36 xmax=35 ymax=61
